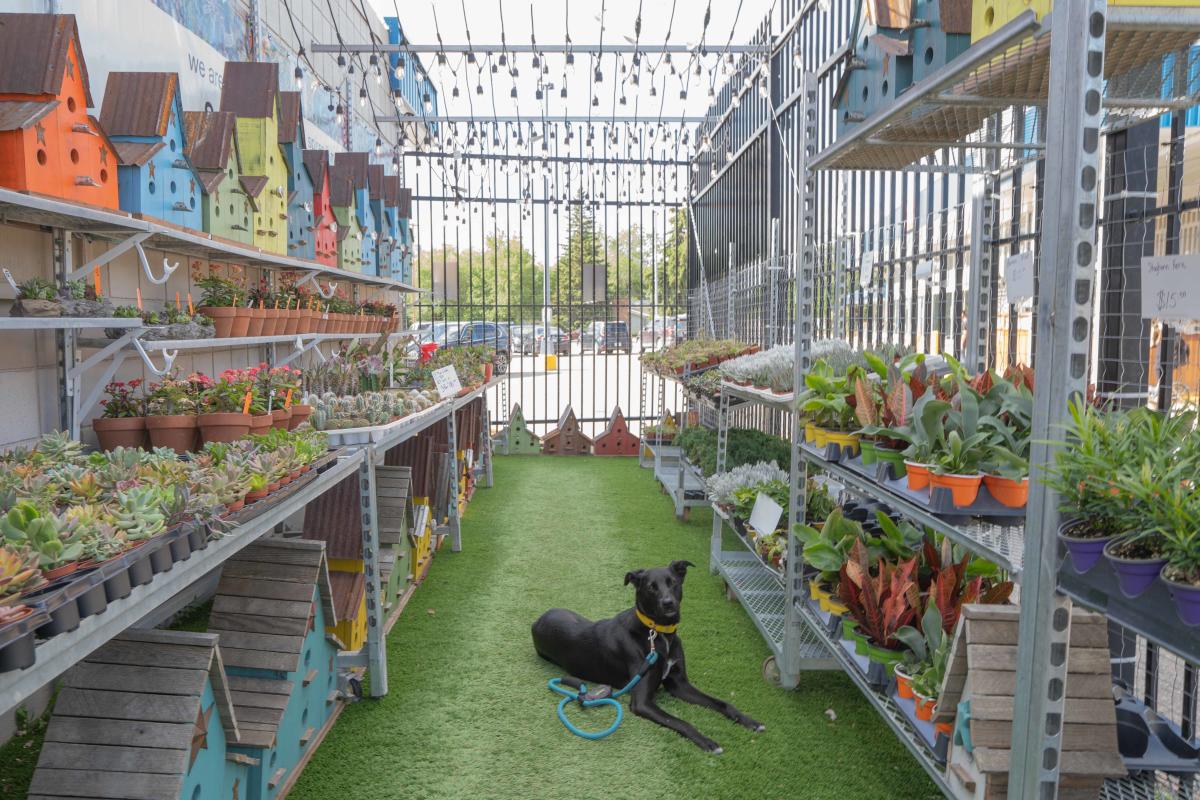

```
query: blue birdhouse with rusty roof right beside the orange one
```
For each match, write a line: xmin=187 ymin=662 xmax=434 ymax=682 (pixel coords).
xmin=100 ymin=72 xmax=204 ymax=230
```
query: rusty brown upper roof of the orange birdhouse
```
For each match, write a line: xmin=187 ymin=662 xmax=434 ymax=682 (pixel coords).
xmin=0 ymin=14 xmax=92 ymax=106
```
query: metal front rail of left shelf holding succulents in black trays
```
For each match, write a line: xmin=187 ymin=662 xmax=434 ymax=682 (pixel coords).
xmin=0 ymin=453 xmax=364 ymax=714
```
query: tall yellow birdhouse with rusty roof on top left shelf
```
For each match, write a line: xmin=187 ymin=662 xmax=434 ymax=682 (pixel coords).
xmin=221 ymin=61 xmax=288 ymax=255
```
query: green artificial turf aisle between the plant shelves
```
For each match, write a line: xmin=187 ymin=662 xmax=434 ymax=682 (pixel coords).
xmin=290 ymin=457 xmax=940 ymax=800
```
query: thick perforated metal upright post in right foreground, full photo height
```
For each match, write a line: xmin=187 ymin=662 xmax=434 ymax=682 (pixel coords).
xmin=1008 ymin=0 xmax=1108 ymax=800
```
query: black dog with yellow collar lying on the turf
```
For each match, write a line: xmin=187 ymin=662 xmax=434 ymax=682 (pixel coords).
xmin=533 ymin=561 xmax=766 ymax=753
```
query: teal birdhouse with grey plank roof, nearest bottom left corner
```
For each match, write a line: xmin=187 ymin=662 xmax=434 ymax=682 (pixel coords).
xmin=30 ymin=630 xmax=246 ymax=800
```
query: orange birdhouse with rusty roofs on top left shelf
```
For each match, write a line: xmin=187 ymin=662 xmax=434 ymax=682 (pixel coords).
xmin=0 ymin=14 xmax=119 ymax=209
